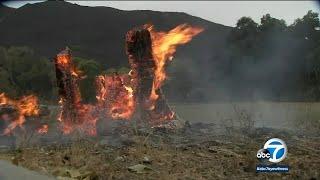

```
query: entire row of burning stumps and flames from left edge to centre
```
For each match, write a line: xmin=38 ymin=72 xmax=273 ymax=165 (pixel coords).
xmin=0 ymin=24 xmax=203 ymax=138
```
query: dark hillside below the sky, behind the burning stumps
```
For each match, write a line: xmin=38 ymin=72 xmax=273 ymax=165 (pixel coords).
xmin=0 ymin=1 xmax=231 ymax=67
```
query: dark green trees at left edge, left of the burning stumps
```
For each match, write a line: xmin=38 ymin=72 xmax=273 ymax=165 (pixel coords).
xmin=0 ymin=47 xmax=54 ymax=99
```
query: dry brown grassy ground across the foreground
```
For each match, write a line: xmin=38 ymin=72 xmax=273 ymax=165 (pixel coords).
xmin=0 ymin=131 xmax=320 ymax=179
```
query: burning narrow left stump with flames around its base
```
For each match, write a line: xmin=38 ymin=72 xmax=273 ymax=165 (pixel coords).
xmin=55 ymin=48 xmax=98 ymax=135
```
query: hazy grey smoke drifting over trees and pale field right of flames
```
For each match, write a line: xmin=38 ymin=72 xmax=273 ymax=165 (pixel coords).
xmin=164 ymin=27 xmax=308 ymax=129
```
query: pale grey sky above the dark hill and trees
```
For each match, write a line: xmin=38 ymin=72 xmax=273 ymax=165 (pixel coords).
xmin=4 ymin=0 xmax=320 ymax=26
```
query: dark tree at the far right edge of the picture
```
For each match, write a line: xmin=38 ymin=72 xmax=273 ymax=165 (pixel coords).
xmin=290 ymin=11 xmax=320 ymax=100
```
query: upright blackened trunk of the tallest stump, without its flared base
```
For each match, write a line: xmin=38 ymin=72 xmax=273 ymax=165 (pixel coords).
xmin=126 ymin=29 xmax=155 ymax=120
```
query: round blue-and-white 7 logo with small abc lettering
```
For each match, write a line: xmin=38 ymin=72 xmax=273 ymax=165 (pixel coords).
xmin=257 ymin=138 xmax=287 ymax=163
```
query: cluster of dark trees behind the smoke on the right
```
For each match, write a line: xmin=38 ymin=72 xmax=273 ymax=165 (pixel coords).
xmin=226 ymin=11 xmax=320 ymax=100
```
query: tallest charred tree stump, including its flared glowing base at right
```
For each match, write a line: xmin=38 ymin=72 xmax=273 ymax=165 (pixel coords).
xmin=126 ymin=28 xmax=176 ymax=126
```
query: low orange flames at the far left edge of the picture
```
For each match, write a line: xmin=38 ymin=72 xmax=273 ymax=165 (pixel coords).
xmin=0 ymin=93 xmax=39 ymax=135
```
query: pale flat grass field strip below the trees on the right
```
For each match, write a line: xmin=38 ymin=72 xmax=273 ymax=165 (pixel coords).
xmin=172 ymin=102 xmax=320 ymax=132
